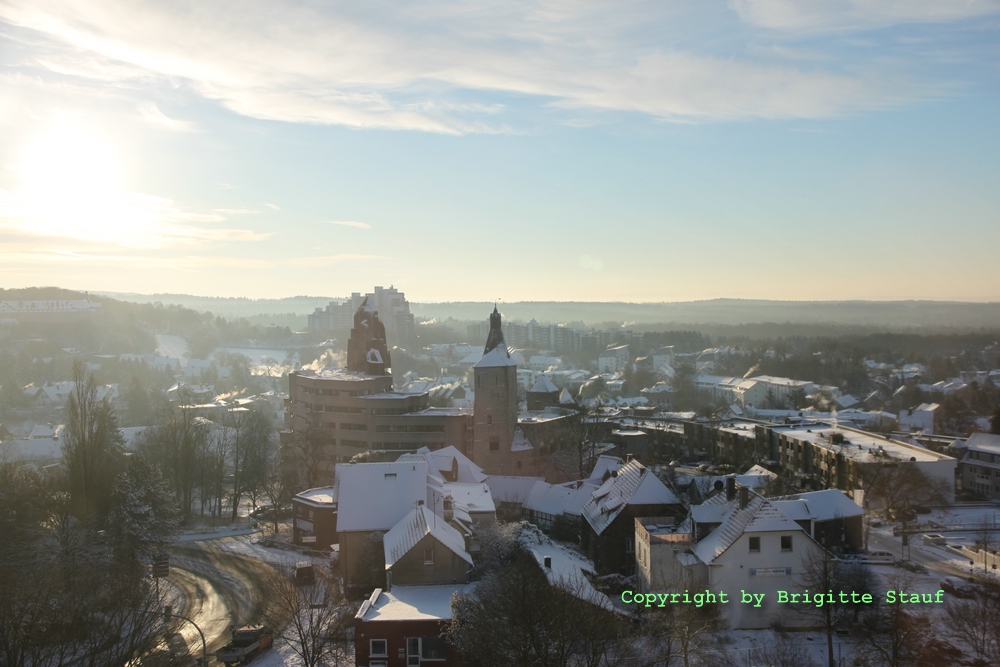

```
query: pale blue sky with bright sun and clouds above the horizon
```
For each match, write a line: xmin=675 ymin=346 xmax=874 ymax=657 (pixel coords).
xmin=0 ymin=0 xmax=1000 ymax=302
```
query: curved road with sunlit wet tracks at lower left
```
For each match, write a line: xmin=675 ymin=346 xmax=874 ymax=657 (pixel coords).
xmin=170 ymin=538 xmax=274 ymax=657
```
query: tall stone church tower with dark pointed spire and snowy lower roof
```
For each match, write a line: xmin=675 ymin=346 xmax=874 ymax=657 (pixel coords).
xmin=472 ymin=306 xmax=524 ymax=475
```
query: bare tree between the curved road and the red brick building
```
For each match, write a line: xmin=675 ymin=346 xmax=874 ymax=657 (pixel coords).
xmin=266 ymin=568 xmax=354 ymax=667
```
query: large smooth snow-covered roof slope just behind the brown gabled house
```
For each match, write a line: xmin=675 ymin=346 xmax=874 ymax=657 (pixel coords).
xmin=337 ymin=461 xmax=427 ymax=532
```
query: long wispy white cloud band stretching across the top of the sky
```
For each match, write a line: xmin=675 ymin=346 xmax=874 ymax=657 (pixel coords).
xmin=0 ymin=0 xmax=976 ymax=134
